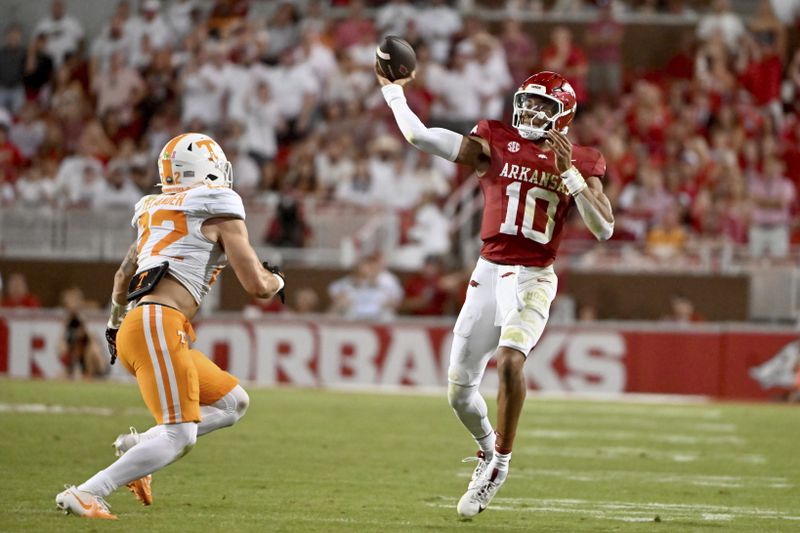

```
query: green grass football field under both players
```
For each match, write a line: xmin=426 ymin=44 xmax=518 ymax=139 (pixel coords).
xmin=0 ymin=380 xmax=800 ymax=533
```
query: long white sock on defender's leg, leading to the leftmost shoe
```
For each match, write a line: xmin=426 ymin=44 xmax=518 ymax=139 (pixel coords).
xmin=78 ymin=422 xmax=197 ymax=498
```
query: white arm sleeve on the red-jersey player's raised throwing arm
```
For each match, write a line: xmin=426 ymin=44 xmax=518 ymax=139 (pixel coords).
xmin=381 ymin=83 xmax=464 ymax=161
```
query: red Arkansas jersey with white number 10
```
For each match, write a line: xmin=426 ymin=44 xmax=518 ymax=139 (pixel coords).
xmin=470 ymin=120 xmax=606 ymax=267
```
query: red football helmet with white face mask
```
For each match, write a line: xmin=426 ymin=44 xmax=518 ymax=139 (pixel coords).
xmin=511 ymin=71 xmax=578 ymax=139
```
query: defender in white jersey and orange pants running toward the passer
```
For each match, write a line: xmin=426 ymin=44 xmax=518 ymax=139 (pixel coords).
xmin=56 ymin=133 xmax=284 ymax=519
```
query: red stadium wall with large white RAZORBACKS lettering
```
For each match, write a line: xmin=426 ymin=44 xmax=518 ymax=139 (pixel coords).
xmin=0 ymin=312 xmax=798 ymax=399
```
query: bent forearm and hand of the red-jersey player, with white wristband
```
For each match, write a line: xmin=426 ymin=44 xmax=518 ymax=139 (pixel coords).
xmin=546 ymin=130 xmax=614 ymax=241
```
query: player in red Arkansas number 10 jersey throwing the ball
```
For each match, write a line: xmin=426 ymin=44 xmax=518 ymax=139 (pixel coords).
xmin=376 ymin=66 xmax=614 ymax=518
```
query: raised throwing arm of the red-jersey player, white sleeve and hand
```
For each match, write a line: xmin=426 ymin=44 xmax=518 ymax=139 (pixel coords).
xmin=375 ymin=68 xmax=489 ymax=173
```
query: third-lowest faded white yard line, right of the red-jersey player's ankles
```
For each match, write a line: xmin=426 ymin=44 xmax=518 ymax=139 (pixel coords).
xmin=521 ymin=446 xmax=767 ymax=464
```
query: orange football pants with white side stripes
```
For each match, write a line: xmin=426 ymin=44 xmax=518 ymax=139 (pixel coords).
xmin=117 ymin=304 xmax=239 ymax=424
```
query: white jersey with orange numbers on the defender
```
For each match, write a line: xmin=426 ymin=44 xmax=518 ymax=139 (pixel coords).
xmin=131 ymin=186 xmax=245 ymax=304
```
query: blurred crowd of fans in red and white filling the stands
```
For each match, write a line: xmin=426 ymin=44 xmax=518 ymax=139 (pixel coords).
xmin=0 ymin=0 xmax=800 ymax=258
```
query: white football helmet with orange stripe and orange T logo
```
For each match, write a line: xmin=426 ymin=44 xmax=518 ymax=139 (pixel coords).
xmin=158 ymin=133 xmax=233 ymax=194
